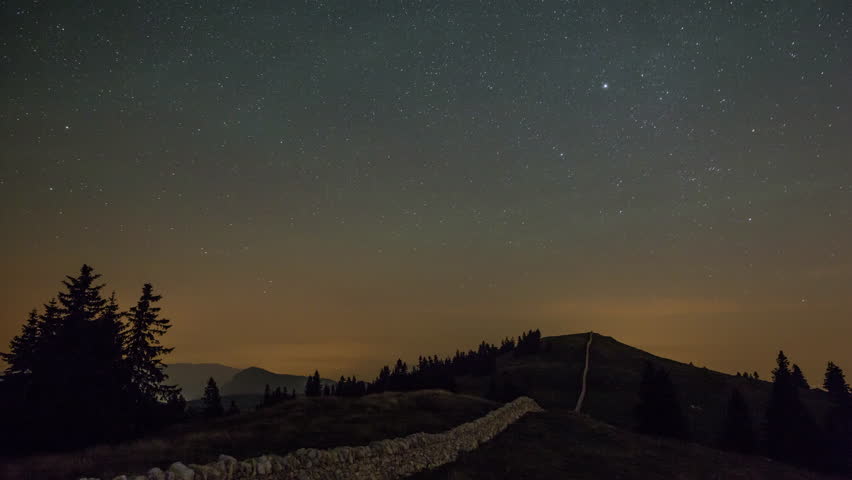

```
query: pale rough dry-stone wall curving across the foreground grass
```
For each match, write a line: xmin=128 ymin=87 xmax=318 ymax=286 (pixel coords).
xmin=81 ymin=397 xmax=542 ymax=480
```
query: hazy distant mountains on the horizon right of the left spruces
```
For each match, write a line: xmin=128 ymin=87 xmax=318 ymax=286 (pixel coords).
xmin=166 ymin=363 xmax=336 ymax=400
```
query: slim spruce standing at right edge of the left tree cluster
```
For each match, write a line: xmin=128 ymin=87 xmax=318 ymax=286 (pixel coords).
xmin=123 ymin=283 xmax=178 ymax=405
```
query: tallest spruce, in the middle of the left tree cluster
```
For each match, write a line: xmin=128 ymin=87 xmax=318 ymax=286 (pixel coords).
xmin=48 ymin=265 xmax=133 ymax=446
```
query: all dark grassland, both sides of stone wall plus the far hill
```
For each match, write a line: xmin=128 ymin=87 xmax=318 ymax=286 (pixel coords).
xmin=0 ymin=334 xmax=840 ymax=480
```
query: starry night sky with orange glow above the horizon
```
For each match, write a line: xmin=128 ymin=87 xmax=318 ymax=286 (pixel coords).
xmin=0 ymin=0 xmax=852 ymax=384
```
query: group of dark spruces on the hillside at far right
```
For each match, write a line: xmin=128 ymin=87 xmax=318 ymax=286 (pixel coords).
xmin=634 ymin=351 xmax=852 ymax=474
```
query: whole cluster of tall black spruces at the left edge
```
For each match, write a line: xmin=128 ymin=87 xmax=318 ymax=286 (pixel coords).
xmin=0 ymin=265 xmax=186 ymax=452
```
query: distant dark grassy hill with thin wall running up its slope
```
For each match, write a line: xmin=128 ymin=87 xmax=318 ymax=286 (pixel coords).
xmin=476 ymin=333 xmax=830 ymax=445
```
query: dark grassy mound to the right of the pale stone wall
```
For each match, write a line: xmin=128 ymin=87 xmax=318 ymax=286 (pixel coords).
xmin=410 ymin=410 xmax=830 ymax=480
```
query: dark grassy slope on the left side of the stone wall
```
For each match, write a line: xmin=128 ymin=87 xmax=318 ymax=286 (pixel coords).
xmin=0 ymin=390 xmax=498 ymax=480
